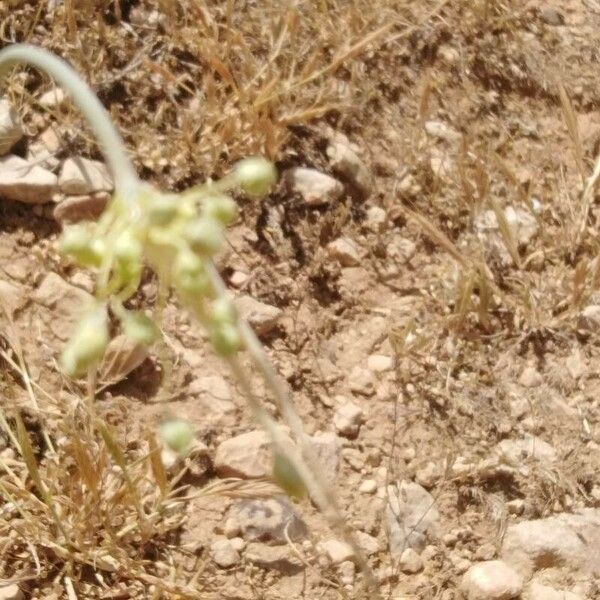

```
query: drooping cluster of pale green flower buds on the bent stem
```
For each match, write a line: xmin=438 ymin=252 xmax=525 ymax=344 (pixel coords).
xmin=60 ymin=158 xmax=277 ymax=377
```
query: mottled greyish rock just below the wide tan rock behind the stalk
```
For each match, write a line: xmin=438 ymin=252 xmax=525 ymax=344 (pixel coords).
xmin=225 ymin=496 xmax=308 ymax=544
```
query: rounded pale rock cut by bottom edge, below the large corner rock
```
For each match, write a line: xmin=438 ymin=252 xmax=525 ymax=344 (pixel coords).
xmin=461 ymin=560 xmax=523 ymax=600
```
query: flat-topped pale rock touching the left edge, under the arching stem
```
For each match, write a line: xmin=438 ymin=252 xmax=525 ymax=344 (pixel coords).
xmin=0 ymin=154 xmax=57 ymax=204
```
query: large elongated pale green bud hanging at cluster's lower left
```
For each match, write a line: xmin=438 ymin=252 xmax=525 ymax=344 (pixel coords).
xmin=60 ymin=306 xmax=109 ymax=377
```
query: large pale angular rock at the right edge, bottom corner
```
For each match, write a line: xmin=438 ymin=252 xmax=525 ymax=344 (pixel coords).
xmin=501 ymin=509 xmax=600 ymax=575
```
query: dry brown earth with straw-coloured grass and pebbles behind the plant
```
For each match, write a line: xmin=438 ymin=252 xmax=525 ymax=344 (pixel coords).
xmin=0 ymin=0 xmax=600 ymax=600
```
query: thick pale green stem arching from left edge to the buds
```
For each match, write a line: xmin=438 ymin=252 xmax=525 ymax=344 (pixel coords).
xmin=0 ymin=44 xmax=140 ymax=205
